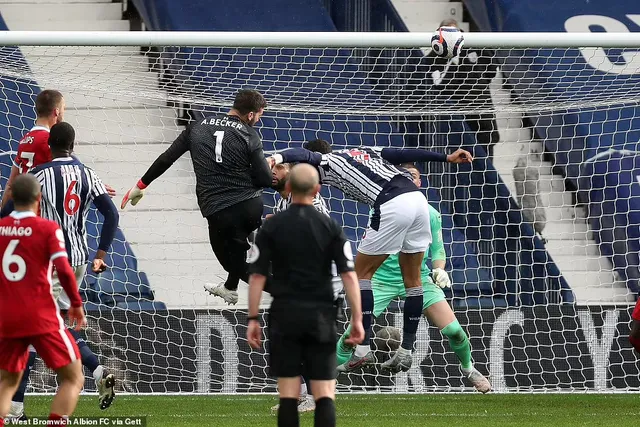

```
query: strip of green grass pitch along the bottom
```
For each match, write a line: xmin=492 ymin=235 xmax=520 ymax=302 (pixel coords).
xmin=26 ymin=393 xmax=640 ymax=427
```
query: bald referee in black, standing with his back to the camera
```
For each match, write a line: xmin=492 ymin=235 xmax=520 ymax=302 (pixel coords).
xmin=247 ymin=164 xmax=364 ymax=427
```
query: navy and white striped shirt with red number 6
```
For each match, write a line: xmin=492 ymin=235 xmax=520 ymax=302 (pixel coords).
xmin=32 ymin=157 xmax=117 ymax=267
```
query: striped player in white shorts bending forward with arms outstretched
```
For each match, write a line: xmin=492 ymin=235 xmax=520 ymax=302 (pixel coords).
xmin=269 ymin=140 xmax=472 ymax=372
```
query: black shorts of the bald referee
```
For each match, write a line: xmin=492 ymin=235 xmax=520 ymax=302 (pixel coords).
xmin=268 ymin=301 xmax=337 ymax=380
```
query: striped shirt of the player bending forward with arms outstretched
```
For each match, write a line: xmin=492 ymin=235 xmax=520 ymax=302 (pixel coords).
xmin=279 ymin=147 xmax=446 ymax=206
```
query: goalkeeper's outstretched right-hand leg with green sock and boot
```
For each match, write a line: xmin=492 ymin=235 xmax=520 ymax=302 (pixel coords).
xmin=424 ymin=300 xmax=491 ymax=393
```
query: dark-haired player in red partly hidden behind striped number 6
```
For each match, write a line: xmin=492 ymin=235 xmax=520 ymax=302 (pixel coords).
xmin=2 ymin=89 xmax=65 ymax=206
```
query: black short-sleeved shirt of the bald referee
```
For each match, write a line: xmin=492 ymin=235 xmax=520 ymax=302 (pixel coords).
xmin=249 ymin=204 xmax=353 ymax=305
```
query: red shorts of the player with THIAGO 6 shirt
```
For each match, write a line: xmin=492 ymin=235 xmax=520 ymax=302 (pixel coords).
xmin=0 ymin=328 xmax=80 ymax=373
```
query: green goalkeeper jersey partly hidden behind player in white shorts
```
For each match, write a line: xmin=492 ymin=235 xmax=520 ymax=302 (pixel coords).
xmin=371 ymin=205 xmax=447 ymax=285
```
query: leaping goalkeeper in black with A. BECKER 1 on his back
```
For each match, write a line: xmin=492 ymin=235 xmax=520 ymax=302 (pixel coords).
xmin=121 ymin=89 xmax=271 ymax=304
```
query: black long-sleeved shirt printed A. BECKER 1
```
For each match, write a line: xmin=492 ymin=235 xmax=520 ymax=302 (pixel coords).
xmin=142 ymin=115 xmax=271 ymax=217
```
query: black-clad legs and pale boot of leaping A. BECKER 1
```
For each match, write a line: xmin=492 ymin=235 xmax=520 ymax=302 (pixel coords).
xmin=205 ymin=197 xmax=264 ymax=304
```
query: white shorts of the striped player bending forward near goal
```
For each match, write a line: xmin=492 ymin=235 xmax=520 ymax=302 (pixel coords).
xmin=358 ymin=191 xmax=431 ymax=255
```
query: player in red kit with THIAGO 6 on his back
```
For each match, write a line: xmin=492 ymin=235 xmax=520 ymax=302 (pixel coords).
xmin=0 ymin=174 xmax=86 ymax=426
